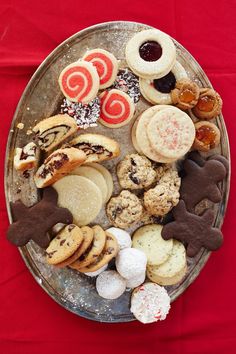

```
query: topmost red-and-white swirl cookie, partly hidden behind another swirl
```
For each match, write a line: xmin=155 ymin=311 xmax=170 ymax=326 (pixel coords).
xmin=83 ymin=48 xmax=118 ymax=89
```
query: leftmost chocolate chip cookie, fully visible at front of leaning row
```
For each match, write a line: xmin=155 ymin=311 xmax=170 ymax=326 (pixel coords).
xmin=46 ymin=224 xmax=83 ymax=264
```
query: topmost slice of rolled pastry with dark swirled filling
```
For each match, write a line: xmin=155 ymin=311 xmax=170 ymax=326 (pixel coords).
xmin=33 ymin=114 xmax=77 ymax=151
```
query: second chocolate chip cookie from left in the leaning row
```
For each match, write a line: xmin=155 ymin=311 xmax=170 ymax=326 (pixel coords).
xmin=56 ymin=226 xmax=93 ymax=268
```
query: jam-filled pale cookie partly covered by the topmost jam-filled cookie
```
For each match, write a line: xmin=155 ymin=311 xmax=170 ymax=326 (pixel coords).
xmin=139 ymin=61 xmax=187 ymax=104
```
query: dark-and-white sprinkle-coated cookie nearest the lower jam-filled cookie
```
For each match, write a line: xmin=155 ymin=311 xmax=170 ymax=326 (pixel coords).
xmin=112 ymin=68 xmax=140 ymax=103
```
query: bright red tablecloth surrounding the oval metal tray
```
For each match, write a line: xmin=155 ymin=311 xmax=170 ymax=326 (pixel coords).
xmin=0 ymin=0 xmax=236 ymax=354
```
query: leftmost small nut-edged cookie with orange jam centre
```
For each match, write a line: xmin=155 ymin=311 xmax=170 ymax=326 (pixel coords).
xmin=171 ymin=79 xmax=200 ymax=110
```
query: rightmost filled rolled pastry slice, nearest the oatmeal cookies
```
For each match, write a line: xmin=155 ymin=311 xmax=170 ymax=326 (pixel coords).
xmin=69 ymin=134 xmax=120 ymax=162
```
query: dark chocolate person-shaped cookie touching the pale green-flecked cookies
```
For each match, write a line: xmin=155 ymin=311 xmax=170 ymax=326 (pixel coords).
xmin=161 ymin=200 xmax=223 ymax=257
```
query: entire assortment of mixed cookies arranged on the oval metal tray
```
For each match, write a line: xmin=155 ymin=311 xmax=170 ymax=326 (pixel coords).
xmin=8 ymin=29 xmax=229 ymax=323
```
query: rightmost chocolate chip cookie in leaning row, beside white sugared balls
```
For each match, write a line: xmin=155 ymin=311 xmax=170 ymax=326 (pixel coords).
xmin=79 ymin=232 xmax=119 ymax=273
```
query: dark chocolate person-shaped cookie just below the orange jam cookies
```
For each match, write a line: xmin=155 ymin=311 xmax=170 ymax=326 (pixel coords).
xmin=180 ymin=159 xmax=227 ymax=212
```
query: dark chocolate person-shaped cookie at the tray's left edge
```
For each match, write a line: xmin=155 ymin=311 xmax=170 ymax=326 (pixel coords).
xmin=7 ymin=187 xmax=73 ymax=248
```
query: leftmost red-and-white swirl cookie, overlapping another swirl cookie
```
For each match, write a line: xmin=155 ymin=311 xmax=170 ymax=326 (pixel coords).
xmin=58 ymin=60 xmax=99 ymax=103
